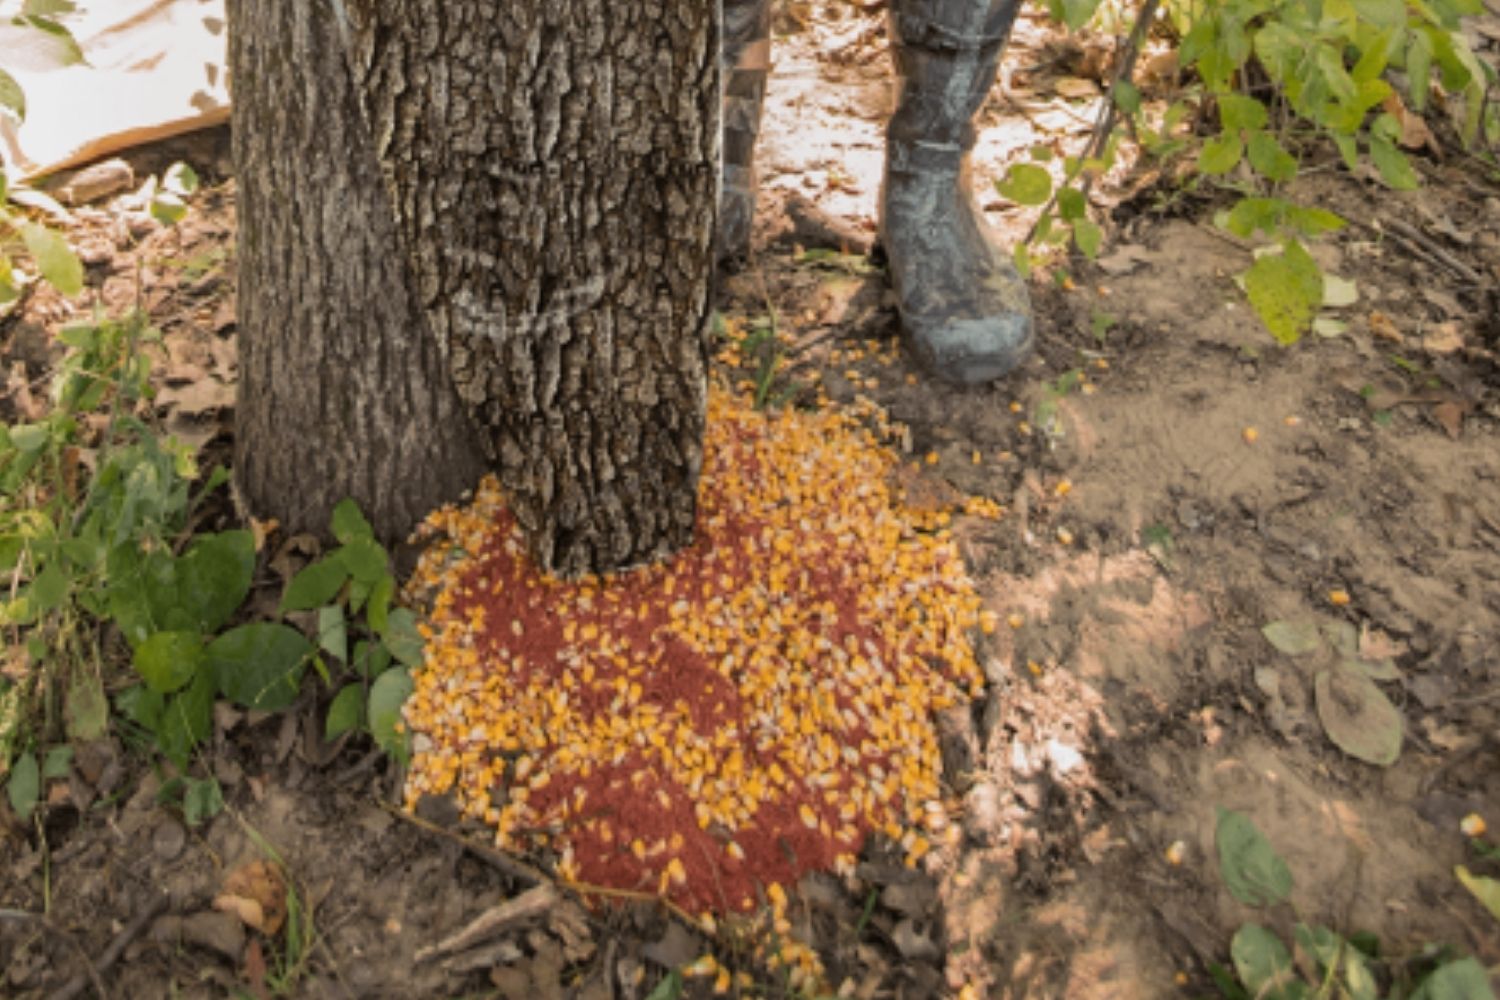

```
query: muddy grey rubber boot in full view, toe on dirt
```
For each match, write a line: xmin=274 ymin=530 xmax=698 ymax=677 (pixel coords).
xmin=881 ymin=0 xmax=1034 ymax=385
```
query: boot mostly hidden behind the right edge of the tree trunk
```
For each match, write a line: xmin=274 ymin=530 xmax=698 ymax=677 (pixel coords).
xmin=714 ymin=0 xmax=771 ymax=264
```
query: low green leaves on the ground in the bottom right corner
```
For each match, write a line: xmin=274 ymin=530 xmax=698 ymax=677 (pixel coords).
xmin=1209 ymin=810 xmax=1494 ymax=1000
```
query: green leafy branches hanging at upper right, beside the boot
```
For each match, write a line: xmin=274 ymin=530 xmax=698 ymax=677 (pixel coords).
xmin=998 ymin=0 xmax=1500 ymax=345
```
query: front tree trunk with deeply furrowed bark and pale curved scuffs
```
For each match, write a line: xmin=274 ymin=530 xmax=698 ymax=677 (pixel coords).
xmin=343 ymin=0 xmax=720 ymax=574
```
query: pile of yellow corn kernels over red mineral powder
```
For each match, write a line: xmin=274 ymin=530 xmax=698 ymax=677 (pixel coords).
xmin=407 ymin=390 xmax=993 ymax=913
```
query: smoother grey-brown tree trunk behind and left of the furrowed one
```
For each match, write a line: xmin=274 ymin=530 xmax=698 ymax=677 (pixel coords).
xmin=228 ymin=0 xmax=485 ymax=543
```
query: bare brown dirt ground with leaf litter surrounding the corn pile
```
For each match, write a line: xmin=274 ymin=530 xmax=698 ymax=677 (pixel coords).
xmin=0 ymin=4 xmax=1500 ymax=997
